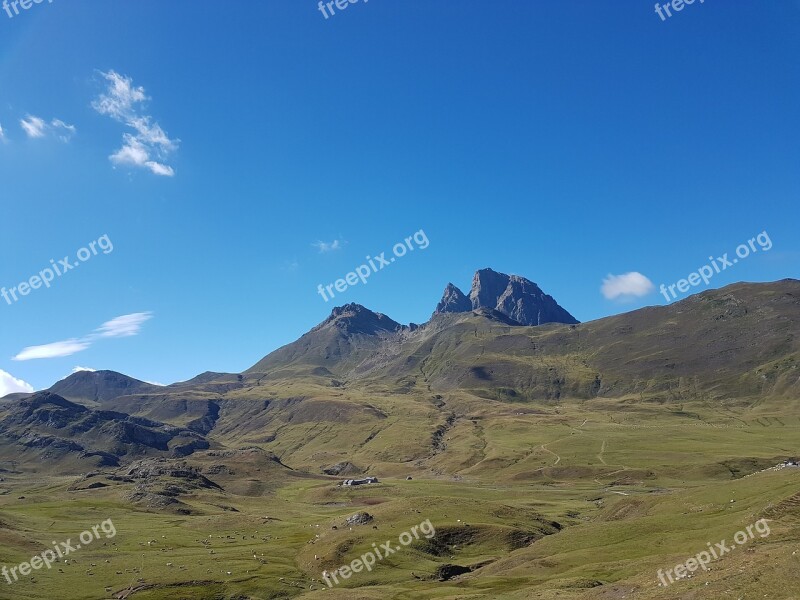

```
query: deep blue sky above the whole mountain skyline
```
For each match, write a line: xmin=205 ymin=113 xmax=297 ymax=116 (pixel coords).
xmin=0 ymin=0 xmax=800 ymax=390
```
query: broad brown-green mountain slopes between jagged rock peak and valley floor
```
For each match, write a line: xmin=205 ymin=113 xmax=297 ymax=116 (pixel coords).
xmin=0 ymin=280 xmax=800 ymax=480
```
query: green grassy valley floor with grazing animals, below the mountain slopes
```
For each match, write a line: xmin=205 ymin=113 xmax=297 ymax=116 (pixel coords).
xmin=0 ymin=401 xmax=800 ymax=600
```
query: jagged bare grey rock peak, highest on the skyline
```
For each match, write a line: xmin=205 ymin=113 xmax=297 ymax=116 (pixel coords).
xmin=434 ymin=269 xmax=578 ymax=325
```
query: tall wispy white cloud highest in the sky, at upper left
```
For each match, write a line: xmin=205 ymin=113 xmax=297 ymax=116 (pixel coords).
xmin=92 ymin=71 xmax=179 ymax=177
